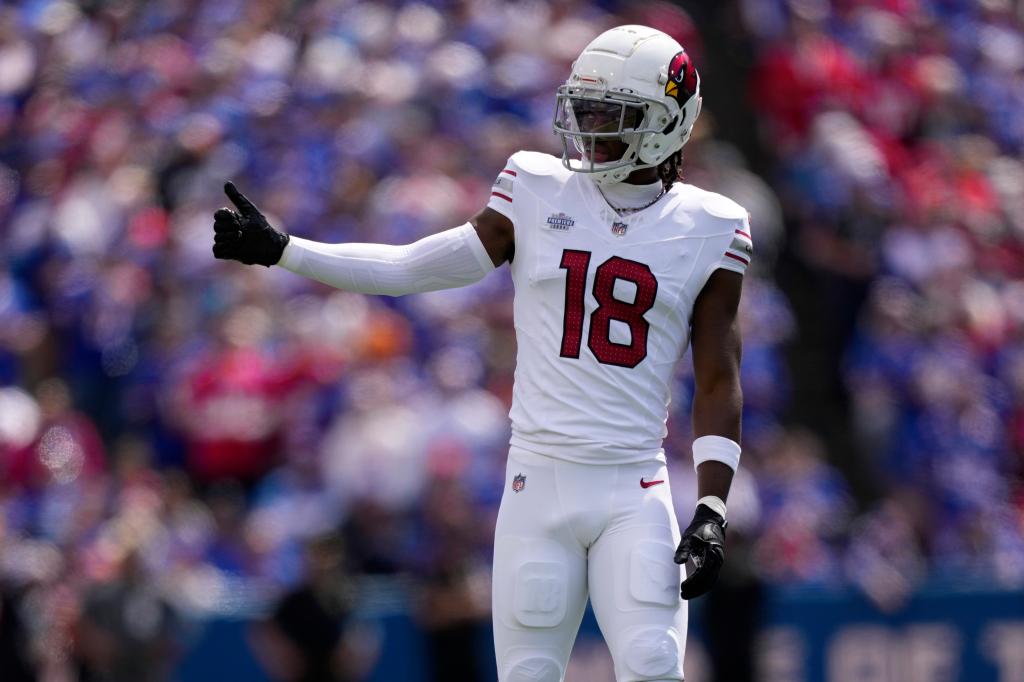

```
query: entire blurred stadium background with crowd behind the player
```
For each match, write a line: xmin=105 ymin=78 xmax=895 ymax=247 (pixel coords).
xmin=0 ymin=0 xmax=1024 ymax=682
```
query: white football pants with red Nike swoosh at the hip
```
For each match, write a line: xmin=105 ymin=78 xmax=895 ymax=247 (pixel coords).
xmin=492 ymin=447 xmax=686 ymax=682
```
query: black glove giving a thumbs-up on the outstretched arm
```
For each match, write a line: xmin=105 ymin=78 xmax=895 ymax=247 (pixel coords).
xmin=213 ymin=182 xmax=288 ymax=267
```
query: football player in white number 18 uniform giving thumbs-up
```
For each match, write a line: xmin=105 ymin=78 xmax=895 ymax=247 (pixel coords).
xmin=213 ymin=26 xmax=753 ymax=682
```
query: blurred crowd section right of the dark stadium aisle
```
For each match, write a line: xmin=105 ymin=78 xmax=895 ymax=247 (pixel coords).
xmin=741 ymin=0 xmax=1024 ymax=593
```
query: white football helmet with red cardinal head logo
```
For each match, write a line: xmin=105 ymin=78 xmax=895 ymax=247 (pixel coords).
xmin=554 ymin=26 xmax=700 ymax=184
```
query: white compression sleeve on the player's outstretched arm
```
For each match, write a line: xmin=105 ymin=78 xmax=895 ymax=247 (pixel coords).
xmin=278 ymin=222 xmax=495 ymax=296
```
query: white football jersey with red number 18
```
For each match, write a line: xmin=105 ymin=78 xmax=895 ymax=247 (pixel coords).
xmin=487 ymin=152 xmax=753 ymax=464
